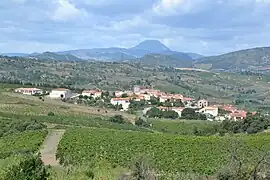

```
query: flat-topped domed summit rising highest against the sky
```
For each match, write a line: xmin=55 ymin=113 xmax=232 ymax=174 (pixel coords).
xmin=131 ymin=40 xmax=171 ymax=53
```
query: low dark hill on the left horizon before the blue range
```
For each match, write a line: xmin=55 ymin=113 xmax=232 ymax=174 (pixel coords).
xmin=28 ymin=52 xmax=82 ymax=61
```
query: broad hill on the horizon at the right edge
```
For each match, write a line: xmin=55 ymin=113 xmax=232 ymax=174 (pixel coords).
xmin=193 ymin=47 xmax=270 ymax=71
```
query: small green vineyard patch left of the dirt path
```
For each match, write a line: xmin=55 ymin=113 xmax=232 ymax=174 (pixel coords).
xmin=0 ymin=130 xmax=47 ymax=159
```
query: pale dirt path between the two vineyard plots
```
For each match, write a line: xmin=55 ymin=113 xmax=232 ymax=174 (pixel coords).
xmin=40 ymin=129 xmax=65 ymax=166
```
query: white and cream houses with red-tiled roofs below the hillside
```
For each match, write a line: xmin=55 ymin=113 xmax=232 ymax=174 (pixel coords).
xmin=15 ymin=86 xmax=251 ymax=121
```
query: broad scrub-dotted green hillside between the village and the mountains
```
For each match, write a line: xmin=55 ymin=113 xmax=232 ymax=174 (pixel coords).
xmin=0 ymin=57 xmax=270 ymax=108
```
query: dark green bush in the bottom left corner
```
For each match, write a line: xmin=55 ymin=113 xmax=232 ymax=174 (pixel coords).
xmin=0 ymin=155 xmax=50 ymax=180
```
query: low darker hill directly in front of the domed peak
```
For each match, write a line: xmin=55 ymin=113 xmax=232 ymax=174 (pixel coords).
xmin=131 ymin=54 xmax=192 ymax=68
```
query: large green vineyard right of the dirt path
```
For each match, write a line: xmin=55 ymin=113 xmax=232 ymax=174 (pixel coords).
xmin=57 ymin=128 xmax=270 ymax=174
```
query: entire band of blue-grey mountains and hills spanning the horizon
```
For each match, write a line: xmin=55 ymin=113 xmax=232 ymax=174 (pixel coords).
xmin=0 ymin=40 xmax=270 ymax=72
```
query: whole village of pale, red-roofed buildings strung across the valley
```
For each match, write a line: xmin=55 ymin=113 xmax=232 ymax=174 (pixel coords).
xmin=14 ymin=86 xmax=252 ymax=121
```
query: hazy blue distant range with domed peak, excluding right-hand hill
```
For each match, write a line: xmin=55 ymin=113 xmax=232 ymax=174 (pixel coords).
xmin=0 ymin=40 xmax=202 ymax=61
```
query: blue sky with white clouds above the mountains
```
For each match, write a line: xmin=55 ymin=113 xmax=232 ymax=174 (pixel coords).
xmin=0 ymin=0 xmax=270 ymax=55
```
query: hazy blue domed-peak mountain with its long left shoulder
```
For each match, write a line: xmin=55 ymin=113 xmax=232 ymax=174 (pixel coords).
xmin=57 ymin=40 xmax=196 ymax=61
